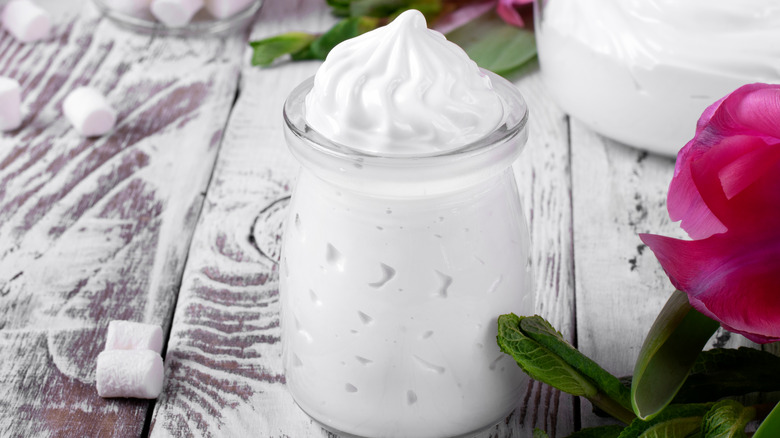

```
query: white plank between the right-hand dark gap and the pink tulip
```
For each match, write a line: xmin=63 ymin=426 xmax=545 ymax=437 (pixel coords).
xmin=571 ymin=123 xmax=681 ymax=427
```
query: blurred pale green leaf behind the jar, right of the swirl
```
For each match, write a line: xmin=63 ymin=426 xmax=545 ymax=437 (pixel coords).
xmin=447 ymin=12 xmax=536 ymax=76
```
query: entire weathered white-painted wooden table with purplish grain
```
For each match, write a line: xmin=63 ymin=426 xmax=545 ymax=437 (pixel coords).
xmin=0 ymin=0 xmax=760 ymax=438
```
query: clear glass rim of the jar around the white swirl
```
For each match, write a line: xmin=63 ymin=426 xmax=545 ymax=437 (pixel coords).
xmin=283 ymin=69 xmax=528 ymax=165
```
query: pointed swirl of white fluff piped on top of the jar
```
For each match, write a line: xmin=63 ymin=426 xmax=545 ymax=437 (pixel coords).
xmin=306 ymin=11 xmax=503 ymax=155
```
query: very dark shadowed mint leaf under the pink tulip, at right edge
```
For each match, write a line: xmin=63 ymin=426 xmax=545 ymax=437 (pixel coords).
xmin=674 ymin=347 xmax=780 ymax=403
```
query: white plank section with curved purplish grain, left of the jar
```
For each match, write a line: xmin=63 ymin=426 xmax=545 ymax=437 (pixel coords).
xmin=151 ymin=0 xmax=333 ymax=437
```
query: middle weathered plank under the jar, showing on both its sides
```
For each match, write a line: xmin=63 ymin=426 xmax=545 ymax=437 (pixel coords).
xmin=151 ymin=0 xmax=574 ymax=437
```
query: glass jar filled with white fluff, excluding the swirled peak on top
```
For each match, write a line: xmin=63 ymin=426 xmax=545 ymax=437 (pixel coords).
xmin=280 ymin=74 xmax=534 ymax=438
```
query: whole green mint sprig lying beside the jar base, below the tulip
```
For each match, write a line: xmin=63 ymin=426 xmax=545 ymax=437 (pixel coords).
xmin=497 ymin=314 xmax=780 ymax=438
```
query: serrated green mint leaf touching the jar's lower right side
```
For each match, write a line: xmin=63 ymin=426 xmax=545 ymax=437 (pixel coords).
xmin=497 ymin=314 xmax=634 ymax=423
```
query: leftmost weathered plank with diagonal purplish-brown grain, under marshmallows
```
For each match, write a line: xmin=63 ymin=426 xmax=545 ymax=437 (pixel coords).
xmin=0 ymin=0 xmax=245 ymax=437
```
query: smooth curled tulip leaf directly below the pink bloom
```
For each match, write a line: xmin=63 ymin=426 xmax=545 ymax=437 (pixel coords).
xmin=631 ymin=291 xmax=718 ymax=419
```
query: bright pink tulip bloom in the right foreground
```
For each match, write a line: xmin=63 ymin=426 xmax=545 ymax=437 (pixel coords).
xmin=640 ymin=84 xmax=780 ymax=343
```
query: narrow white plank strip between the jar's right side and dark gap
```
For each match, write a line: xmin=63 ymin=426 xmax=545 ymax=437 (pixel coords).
xmin=514 ymin=69 xmax=575 ymax=437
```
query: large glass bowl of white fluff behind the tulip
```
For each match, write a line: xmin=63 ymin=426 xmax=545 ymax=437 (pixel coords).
xmin=536 ymin=0 xmax=780 ymax=155
